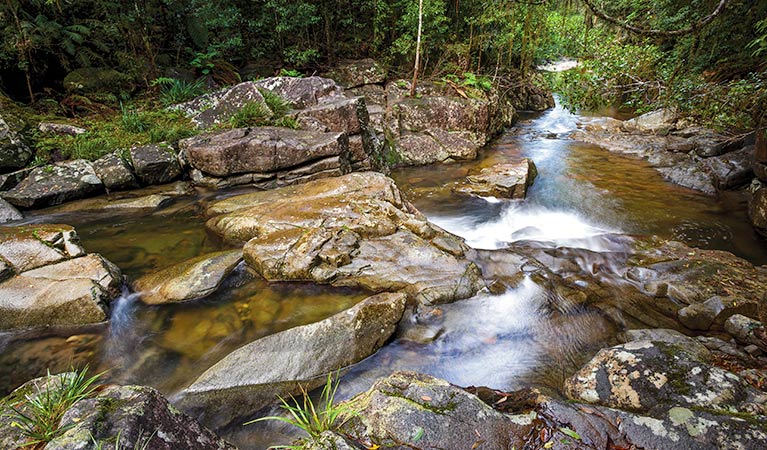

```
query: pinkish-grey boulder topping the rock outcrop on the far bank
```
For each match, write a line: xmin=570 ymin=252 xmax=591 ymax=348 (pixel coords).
xmin=255 ymin=77 xmax=343 ymax=109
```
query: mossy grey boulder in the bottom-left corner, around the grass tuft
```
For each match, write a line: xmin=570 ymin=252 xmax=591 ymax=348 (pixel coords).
xmin=0 ymin=374 xmax=236 ymax=450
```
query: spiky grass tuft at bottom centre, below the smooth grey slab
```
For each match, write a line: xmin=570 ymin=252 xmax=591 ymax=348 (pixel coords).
xmin=245 ymin=374 xmax=355 ymax=449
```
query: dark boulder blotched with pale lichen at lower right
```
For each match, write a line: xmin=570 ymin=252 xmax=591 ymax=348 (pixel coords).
xmin=565 ymin=340 xmax=767 ymax=417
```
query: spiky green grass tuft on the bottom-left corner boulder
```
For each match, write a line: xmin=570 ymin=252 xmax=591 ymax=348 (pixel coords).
xmin=3 ymin=366 xmax=103 ymax=445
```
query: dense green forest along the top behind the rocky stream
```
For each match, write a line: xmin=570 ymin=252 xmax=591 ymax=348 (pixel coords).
xmin=0 ymin=0 xmax=767 ymax=133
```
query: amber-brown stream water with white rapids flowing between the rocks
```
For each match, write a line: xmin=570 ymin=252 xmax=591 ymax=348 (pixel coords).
xmin=0 ymin=97 xmax=767 ymax=449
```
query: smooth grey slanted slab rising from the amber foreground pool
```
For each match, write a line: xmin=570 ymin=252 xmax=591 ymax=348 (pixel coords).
xmin=177 ymin=294 xmax=405 ymax=428
